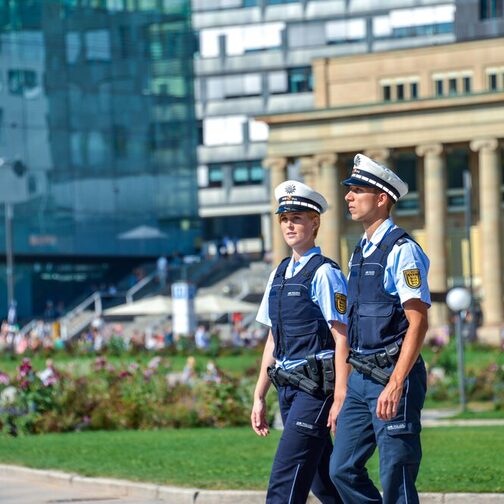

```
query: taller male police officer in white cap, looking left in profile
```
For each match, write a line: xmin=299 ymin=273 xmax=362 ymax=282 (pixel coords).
xmin=330 ymin=154 xmax=430 ymax=504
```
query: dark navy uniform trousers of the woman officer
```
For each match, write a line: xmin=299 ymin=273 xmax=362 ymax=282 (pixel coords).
xmin=266 ymin=385 xmax=342 ymax=504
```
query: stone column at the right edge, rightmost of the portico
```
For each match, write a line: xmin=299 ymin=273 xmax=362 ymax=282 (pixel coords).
xmin=471 ymin=138 xmax=504 ymax=326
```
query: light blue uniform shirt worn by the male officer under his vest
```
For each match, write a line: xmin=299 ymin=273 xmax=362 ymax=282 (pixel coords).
xmin=349 ymin=218 xmax=431 ymax=306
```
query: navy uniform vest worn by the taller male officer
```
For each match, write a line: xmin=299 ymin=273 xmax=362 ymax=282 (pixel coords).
xmin=348 ymin=228 xmax=411 ymax=353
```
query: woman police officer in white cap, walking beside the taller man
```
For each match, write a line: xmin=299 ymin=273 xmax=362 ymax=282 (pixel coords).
xmin=251 ymin=180 xmax=350 ymax=504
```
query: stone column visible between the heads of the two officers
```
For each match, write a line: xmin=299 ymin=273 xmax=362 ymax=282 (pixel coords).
xmin=314 ymin=154 xmax=343 ymax=264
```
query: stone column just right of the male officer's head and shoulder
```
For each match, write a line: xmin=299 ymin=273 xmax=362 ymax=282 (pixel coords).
xmin=416 ymin=144 xmax=448 ymax=328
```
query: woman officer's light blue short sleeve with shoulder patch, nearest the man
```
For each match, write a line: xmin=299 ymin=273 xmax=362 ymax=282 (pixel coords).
xmin=312 ymin=263 xmax=347 ymax=325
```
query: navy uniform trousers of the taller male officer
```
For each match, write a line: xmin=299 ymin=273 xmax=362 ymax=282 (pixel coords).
xmin=330 ymin=358 xmax=426 ymax=504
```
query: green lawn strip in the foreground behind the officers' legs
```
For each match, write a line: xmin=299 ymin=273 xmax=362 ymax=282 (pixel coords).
xmin=0 ymin=427 xmax=504 ymax=492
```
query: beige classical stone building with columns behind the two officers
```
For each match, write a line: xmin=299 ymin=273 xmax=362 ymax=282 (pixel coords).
xmin=259 ymin=38 xmax=504 ymax=340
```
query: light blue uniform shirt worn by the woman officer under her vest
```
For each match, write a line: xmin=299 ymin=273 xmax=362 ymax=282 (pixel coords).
xmin=256 ymin=247 xmax=347 ymax=369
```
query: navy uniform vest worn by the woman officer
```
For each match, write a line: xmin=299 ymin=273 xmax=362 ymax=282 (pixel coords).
xmin=268 ymin=254 xmax=339 ymax=360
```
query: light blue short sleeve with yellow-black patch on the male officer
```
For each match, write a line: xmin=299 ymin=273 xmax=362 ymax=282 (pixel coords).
xmin=385 ymin=240 xmax=431 ymax=306
